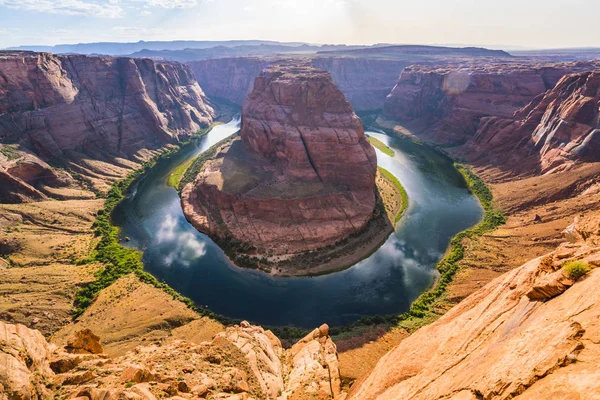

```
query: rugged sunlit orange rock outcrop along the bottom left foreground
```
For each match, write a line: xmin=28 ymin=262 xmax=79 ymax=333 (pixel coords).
xmin=0 ymin=322 xmax=341 ymax=400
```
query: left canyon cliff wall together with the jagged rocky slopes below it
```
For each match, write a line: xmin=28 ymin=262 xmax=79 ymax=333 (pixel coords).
xmin=0 ymin=52 xmax=215 ymax=202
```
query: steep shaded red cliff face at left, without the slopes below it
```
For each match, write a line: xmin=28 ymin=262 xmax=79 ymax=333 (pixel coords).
xmin=0 ymin=52 xmax=214 ymax=158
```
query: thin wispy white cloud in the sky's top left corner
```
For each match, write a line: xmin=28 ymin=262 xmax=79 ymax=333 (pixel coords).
xmin=0 ymin=0 xmax=123 ymax=18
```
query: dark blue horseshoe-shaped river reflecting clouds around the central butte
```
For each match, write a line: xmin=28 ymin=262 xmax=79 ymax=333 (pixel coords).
xmin=113 ymin=120 xmax=482 ymax=328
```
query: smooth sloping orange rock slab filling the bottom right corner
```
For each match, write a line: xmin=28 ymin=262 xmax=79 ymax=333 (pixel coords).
xmin=348 ymin=218 xmax=600 ymax=400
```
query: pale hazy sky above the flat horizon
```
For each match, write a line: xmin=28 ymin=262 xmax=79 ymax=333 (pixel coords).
xmin=0 ymin=0 xmax=600 ymax=48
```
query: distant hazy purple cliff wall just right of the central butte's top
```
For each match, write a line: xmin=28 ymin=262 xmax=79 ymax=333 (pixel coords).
xmin=312 ymin=57 xmax=411 ymax=110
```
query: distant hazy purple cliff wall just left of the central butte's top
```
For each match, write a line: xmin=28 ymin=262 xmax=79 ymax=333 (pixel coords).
xmin=188 ymin=57 xmax=268 ymax=105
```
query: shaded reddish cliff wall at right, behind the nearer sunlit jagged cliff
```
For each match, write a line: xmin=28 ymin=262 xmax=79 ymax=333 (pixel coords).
xmin=382 ymin=62 xmax=597 ymax=145
